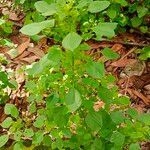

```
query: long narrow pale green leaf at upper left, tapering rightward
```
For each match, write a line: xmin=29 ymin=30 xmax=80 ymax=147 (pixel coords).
xmin=20 ymin=19 xmax=54 ymax=36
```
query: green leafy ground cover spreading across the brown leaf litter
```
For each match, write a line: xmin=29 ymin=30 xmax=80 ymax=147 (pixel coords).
xmin=0 ymin=0 xmax=150 ymax=150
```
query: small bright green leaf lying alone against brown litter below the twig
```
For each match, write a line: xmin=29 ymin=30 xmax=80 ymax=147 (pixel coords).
xmin=102 ymin=48 xmax=119 ymax=59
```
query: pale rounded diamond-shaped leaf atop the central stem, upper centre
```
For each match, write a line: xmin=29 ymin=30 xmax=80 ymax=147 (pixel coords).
xmin=62 ymin=32 xmax=82 ymax=51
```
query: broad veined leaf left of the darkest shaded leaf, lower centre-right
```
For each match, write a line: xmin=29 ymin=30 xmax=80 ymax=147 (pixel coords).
xmin=85 ymin=112 xmax=102 ymax=131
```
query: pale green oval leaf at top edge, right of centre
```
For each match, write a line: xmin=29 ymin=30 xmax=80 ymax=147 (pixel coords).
xmin=88 ymin=1 xmax=110 ymax=13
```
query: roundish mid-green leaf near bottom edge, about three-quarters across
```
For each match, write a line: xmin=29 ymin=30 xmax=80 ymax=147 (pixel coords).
xmin=110 ymin=131 xmax=125 ymax=147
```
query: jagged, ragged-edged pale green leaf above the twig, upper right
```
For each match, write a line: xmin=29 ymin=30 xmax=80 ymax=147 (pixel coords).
xmin=93 ymin=22 xmax=117 ymax=40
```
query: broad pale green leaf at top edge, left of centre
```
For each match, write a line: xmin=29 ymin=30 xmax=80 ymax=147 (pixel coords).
xmin=34 ymin=1 xmax=57 ymax=16
